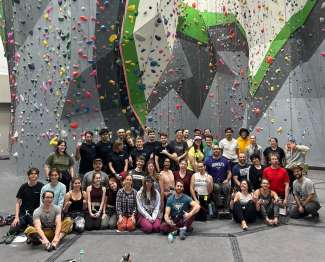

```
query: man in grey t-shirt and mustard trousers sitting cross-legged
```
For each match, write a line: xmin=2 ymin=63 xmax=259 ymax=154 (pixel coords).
xmin=24 ymin=191 xmax=73 ymax=252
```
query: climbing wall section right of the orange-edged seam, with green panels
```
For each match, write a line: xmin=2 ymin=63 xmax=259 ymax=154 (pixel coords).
xmin=122 ymin=0 xmax=325 ymax=165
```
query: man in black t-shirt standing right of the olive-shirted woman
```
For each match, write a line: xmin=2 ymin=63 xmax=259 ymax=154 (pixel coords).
xmin=75 ymin=131 xmax=96 ymax=180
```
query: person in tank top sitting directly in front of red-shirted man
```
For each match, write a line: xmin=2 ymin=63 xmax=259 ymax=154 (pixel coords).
xmin=254 ymin=178 xmax=279 ymax=225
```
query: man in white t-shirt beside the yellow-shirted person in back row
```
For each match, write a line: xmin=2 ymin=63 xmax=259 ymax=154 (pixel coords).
xmin=219 ymin=127 xmax=239 ymax=167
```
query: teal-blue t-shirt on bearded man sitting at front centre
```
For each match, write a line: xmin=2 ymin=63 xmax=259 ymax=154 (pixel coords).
xmin=166 ymin=194 xmax=193 ymax=221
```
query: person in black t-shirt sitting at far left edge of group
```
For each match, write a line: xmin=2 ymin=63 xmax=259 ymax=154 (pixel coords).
xmin=1 ymin=167 xmax=44 ymax=244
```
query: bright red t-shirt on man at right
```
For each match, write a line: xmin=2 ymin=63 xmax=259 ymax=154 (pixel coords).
xmin=263 ymin=166 xmax=289 ymax=197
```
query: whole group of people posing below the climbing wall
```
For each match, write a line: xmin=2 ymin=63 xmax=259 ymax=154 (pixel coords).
xmin=1 ymin=128 xmax=320 ymax=251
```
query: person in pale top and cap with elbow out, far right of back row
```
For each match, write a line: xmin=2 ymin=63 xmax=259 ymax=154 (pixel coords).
xmin=285 ymin=138 xmax=310 ymax=189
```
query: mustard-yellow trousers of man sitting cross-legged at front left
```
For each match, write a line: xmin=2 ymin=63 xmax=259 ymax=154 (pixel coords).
xmin=24 ymin=218 xmax=73 ymax=244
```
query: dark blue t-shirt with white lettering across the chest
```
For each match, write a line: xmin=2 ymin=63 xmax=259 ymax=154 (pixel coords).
xmin=205 ymin=156 xmax=230 ymax=183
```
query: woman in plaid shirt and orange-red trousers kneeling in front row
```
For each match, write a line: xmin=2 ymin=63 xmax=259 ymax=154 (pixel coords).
xmin=116 ymin=174 xmax=137 ymax=232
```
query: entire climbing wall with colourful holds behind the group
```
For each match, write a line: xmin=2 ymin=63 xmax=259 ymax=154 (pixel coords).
xmin=5 ymin=0 xmax=325 ymax=172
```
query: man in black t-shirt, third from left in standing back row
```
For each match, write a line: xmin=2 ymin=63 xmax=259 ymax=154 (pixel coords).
xmin=96 ymin=128 xmax=112 ymax=172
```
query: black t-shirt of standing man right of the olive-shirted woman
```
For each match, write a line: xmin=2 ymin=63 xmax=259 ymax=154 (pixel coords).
xmin=79 ymin=143 xmax=96 ymax=174
